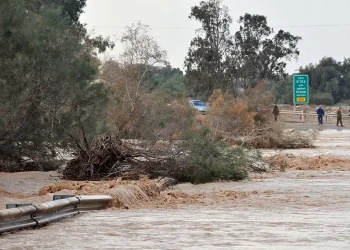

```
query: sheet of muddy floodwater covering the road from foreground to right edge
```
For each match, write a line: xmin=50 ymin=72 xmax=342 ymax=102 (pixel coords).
xmin=0 ymin=130 xmax=350 ymax=249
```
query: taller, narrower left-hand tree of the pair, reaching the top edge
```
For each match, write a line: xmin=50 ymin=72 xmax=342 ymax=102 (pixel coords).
xmin=185 ymin=0 xmax=236 ymax=97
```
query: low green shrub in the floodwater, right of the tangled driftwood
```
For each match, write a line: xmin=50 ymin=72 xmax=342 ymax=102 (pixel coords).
xmin=172 ymin=131 xmax=255 ymax=184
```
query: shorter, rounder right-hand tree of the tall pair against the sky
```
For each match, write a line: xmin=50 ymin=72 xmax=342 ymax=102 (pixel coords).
xmin=233 ymin=14 xmax=301 ymax=89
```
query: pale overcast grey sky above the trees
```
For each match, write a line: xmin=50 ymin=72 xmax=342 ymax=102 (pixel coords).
xmin=81 ymin=0 xmax=350 ymax=73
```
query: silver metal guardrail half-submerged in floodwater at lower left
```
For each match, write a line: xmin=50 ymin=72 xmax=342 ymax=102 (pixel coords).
xmin=0 ymin=195 xmax=112 ymax=234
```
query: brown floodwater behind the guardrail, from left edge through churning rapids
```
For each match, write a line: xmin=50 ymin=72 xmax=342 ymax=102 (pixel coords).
xmin=0 ymin=172 xmax=248 ymax=209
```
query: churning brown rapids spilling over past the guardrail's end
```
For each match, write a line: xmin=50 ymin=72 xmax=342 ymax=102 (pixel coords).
xmin=39 ymin=177 xmax=247 ymax=209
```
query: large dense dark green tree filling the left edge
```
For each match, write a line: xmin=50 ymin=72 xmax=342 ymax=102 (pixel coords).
xmin=0 ymin=0 xmax=111 ymax=168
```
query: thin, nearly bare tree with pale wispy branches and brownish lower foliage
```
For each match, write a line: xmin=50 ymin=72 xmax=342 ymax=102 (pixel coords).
xmin=101 ymin=23 xmax=172 ymax=138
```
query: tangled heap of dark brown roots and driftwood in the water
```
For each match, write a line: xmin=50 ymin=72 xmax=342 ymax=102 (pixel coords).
xmin=63 ymin=137 xmax=180 ymax=180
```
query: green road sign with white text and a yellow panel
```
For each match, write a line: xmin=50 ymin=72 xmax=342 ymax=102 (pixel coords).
xmin=293 ymin=75 xmax=309 ymax=104
